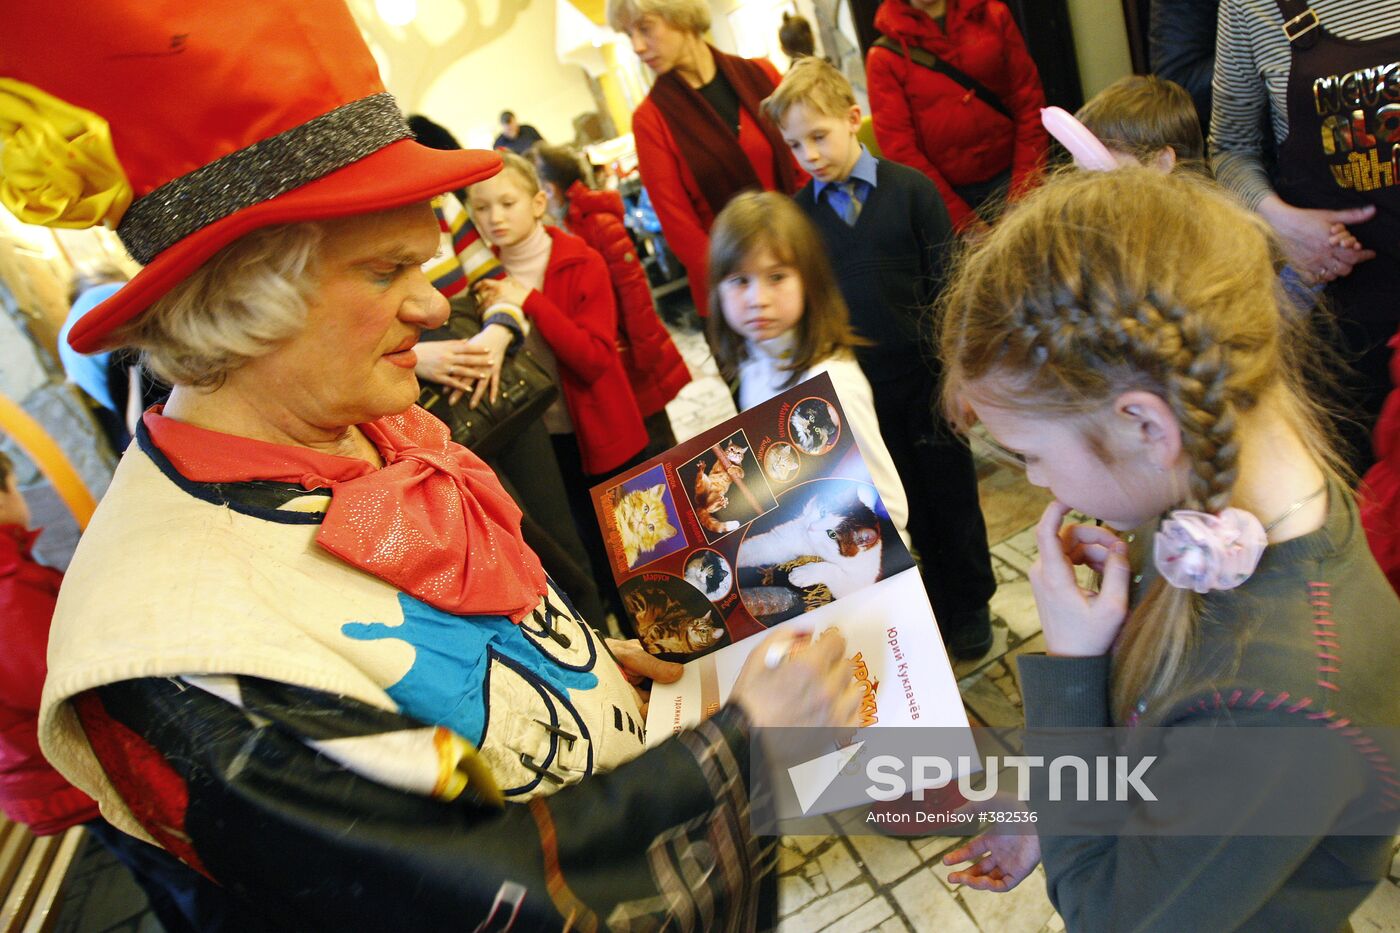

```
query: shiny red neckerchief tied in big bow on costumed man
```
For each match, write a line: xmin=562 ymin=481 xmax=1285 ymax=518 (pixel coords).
xmin=144 ymin=405 xmax=546 ymax=622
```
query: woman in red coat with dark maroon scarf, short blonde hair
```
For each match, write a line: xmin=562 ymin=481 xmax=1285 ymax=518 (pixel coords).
xmin=608 ymin=0 xmax=806 ymax=315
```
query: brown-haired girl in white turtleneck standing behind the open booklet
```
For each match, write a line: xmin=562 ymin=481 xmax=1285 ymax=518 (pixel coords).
xmin=706 ymin=192 xmax=909 ymax=545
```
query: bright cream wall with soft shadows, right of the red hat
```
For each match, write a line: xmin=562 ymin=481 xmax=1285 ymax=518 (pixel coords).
xmin=350 ymin=0 xmax=598 ymax=148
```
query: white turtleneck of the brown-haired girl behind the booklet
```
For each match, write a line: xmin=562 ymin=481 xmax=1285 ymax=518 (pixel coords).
xmin=739 ymin=329 xmax=909 ymax=546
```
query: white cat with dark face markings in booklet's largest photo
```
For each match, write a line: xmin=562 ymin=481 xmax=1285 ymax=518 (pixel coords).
xmin=739 ymin=483 xmax=883 ymax=600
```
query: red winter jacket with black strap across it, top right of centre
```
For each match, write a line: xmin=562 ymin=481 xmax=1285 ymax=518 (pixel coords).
xmin=865 ymin=0 xmax=1050 ymax=230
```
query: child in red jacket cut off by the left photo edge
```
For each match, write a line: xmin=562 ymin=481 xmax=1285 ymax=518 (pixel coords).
xmin=0 ymin=454 xmax=265 ymax=933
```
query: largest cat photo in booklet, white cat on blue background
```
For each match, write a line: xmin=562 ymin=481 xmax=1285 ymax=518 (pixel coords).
xmin=736 ymin=479 xmax=914 ymax=626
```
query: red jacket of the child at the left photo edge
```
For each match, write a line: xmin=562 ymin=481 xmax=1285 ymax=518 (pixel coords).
xmin=0 ymin=525 xmax=98 ymax=836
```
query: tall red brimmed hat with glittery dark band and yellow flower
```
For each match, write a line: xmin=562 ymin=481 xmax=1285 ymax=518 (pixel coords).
xmin=0 ymin=0 xmax=501 ymax=353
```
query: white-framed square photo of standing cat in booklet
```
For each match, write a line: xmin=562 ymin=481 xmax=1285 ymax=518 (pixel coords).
xmin=676 ymin=430 xmax=777 ymax=544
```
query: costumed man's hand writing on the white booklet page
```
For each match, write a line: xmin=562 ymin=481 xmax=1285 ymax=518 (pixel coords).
xmin=729 ymin=629 xmax=861 ymax=728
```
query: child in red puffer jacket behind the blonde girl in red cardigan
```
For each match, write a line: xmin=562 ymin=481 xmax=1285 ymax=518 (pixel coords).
xmin=533 ymin=146 xmax=690 ymax=454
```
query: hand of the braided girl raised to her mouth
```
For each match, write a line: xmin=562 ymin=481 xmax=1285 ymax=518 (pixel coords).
xmin=1028 ymin=502 xmax=1128 ymax=657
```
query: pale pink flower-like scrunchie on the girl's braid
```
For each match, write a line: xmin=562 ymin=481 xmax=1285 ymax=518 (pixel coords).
xmin=1152 ymin=509 xmax=1268 ymax=593
